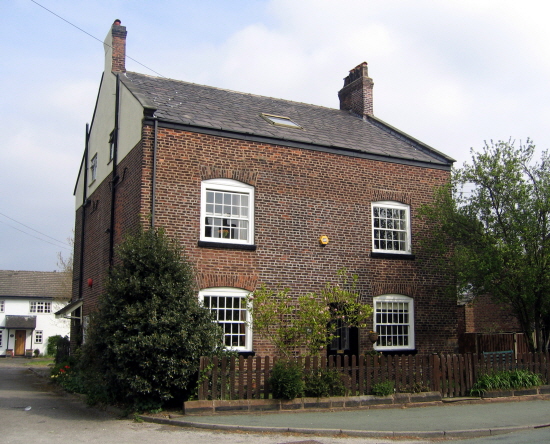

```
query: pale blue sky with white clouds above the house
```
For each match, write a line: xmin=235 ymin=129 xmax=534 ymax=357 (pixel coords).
xmin=0 ymin=0 xmax=550 ymax=271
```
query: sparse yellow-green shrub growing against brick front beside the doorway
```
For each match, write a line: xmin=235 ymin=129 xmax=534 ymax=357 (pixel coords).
xmin=248 ymin=269 xmax=372 ymax=359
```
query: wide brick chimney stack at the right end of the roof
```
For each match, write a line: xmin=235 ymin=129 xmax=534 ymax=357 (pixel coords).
xmin=338 ymin=62 xmax=374 ymax=117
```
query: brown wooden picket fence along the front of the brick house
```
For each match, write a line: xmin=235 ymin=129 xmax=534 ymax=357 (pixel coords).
xmin=198 ymin=352 xmax=550 ymax=400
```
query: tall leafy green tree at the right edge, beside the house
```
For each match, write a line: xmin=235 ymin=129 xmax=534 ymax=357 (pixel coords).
xmin=421 ymin=140 xmax=550 ymax=351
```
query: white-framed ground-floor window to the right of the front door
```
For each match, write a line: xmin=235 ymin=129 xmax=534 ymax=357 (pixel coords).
xmin=373 ymin=294 xmax=415 ymax=350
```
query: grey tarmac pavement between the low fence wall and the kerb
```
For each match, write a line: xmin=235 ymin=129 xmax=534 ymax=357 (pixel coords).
xmin=144 ymin=397 xmax=550 ymax=439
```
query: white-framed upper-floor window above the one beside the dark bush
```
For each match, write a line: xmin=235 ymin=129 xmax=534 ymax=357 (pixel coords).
xmin=200 ymin=179 xmax=254 ymax=245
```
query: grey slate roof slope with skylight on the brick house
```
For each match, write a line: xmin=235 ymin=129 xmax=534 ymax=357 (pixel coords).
xmin=121 ymin=72 xmax=453 ymax=167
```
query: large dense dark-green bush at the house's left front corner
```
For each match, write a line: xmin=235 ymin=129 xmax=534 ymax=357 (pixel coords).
xmin=82 ymin=229 xmax=223 ymax=410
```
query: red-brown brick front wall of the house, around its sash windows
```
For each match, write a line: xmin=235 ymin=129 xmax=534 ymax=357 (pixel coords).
xmin=137 ymin=128 xmax=457 ymax=355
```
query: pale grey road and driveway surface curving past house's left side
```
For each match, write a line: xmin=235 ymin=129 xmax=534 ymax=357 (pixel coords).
xmin=0 ymin=358 xmax=414 ymax=444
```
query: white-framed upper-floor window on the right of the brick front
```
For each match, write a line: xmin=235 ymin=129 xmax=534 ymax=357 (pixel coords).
xmin=372 ymin=202 xmax=411 ymax=254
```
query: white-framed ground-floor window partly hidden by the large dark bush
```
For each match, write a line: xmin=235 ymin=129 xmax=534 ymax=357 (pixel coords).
xmin=199 ymin=288 xmax=252 ymax=351
